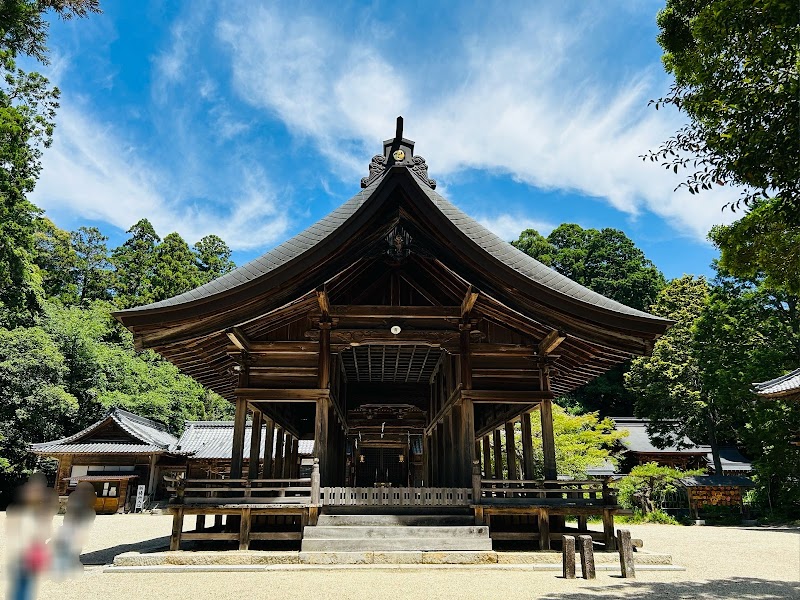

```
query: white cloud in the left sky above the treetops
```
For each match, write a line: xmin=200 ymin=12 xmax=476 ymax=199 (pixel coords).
xmin=33 ymin=105 xmax=289 ymax=250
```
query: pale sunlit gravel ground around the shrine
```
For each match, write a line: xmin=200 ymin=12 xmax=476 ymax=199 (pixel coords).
xmin=0 ymin=515 xmax=800 ymax=600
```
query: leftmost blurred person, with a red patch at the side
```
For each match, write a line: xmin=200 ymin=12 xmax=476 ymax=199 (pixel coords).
xmin=6 ymin=472 xmax=58 ymax=600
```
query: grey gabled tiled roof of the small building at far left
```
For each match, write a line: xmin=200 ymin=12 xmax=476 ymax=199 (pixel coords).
xmin=31 ymin=407 xmax=177 ymax=454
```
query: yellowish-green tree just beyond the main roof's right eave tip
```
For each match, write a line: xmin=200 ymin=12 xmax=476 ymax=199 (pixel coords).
xmin=625 ymin=275 xmax=738 ymax=473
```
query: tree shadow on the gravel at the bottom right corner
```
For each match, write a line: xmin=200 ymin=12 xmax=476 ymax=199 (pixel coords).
xmin=540 ymin=573 xmax=800 ymax=600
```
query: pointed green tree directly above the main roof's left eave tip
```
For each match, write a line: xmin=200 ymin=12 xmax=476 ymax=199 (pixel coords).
xmin=111 ymin=219 xmax=161 ymax=308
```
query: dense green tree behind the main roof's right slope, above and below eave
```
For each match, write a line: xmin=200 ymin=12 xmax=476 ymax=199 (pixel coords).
xmin=512 ymin=223 xmax=664 ymax=415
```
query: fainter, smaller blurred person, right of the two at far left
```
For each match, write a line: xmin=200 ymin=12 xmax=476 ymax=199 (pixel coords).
xmin=51 ymin=481 xmax=97 ymax=577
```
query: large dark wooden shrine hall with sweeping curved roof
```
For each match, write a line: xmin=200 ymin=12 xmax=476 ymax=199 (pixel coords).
xmin=115 ymin=119 xmax=670 ymax=548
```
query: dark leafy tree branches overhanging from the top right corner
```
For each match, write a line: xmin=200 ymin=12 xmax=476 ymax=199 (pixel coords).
xmin=651 ymin=0 xmax=800 ymax=216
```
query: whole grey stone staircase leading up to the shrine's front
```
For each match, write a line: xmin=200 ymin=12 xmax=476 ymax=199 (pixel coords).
xmin=301 ymin=515 xmax=492 ymax=553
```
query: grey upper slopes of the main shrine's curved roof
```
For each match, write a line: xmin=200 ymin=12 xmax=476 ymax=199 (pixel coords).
xmin=115 ymin=164 xmax=669 ymax=322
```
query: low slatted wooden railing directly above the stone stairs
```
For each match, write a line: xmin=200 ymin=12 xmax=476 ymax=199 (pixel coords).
xmin=321 ymin=487 xmax=472 ymax=506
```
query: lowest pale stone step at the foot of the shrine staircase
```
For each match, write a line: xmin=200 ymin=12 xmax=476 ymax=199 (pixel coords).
xmin=301 ymin=536 xmax=492 ymax=552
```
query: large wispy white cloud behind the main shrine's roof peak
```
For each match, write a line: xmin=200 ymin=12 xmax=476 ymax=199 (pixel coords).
xmin=217 ymin=5 xmax=736 ymax=239
